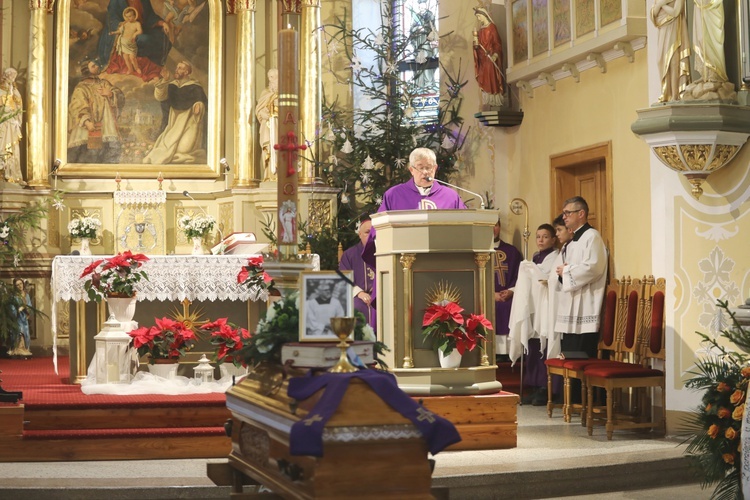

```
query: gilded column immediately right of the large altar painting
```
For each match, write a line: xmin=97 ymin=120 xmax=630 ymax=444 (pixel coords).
xmin=230 ymin=0 xmax=261 ymax=187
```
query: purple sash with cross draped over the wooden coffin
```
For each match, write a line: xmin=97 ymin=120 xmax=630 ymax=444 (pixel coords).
xmin=287 ymin=370 xmax=461 ymax=457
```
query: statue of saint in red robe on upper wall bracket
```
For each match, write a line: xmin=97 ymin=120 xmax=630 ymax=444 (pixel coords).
xmin=474 ymin=7 xmax=505 ymax=106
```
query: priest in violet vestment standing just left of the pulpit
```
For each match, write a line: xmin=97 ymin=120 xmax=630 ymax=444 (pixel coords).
xmin=339 ymin=215 xmax=377 ymax=331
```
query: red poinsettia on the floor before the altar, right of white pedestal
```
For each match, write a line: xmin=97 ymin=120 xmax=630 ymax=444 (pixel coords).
xmin=128 ymin=317 xmax=195 ymax=364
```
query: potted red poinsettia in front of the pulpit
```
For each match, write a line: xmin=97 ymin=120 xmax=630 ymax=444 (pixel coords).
xmin=422 ymin=301 xmax=492 ymax=368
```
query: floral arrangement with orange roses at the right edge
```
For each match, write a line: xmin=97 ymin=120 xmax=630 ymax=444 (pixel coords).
xmin=683 ymin=300 xmax=750 ymax=499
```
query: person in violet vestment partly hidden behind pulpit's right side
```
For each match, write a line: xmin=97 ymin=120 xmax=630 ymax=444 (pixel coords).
xmin=493 ymin=218 xmax=523 ymax=356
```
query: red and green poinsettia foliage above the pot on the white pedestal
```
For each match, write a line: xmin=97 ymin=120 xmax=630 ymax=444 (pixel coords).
xmin=81 ymin=250 xmax=148 ymax=302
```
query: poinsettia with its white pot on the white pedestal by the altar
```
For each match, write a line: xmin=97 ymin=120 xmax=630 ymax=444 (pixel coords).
xmin=81 ymin=250 xmax=148 ymax=322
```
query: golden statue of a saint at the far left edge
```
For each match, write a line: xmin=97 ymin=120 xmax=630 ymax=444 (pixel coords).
xmin=0 ymin=68 xmax=26 ymax=186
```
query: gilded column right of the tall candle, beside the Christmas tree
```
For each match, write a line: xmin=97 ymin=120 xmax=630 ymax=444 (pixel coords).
xmin=299 ymin=0 xmax=323 ymax=184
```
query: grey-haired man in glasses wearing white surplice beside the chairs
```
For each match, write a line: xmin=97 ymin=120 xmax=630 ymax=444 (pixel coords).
xmin=555 ymin=196 xmax=607 ymax=403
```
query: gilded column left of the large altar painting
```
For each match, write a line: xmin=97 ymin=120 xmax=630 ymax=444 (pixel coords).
xmin=26 ymin=0 xmax=55 ymax=189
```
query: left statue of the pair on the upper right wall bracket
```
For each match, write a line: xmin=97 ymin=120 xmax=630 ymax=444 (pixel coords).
xmin=651 ymin=0 xmax=690 ymax=102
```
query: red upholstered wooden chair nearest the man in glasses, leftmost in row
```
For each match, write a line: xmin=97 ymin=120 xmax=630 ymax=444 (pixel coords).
xmin=545 ymin=276 xmax=631 ymax=426
